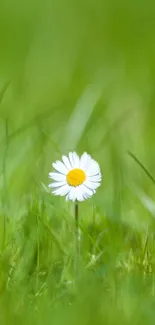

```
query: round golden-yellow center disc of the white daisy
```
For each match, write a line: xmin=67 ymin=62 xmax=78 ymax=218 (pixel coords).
xmin=67 ymin=168 xmax=86 ymax=186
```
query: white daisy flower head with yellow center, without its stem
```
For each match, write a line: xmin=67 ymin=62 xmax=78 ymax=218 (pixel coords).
xmin=49 ymin=152 xmax=102 ymax=201
